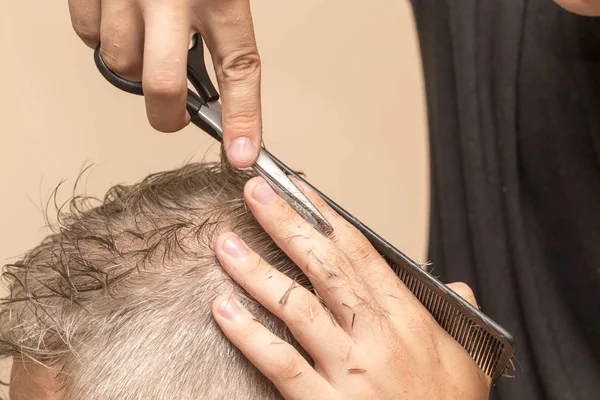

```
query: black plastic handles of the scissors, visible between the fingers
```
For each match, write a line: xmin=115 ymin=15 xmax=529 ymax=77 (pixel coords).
xmin=94 ymin=34 xmax=223 ymax=141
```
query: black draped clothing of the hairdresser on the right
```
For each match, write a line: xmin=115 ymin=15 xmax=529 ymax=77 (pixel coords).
xmin=413 ymin=0 xmax=600 ymax=400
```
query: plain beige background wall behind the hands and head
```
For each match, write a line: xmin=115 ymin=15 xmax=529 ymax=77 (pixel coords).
xmin=0 ymin=0 xmax=428 ymax=396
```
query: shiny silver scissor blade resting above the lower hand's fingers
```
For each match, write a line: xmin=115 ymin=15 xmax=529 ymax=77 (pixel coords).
xmin=254 ymin=149 xmax=333 ymax=236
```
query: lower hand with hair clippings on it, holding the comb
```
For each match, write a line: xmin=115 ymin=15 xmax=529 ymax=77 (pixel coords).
xmin=213 ymin=178 xmax=490 ymax=400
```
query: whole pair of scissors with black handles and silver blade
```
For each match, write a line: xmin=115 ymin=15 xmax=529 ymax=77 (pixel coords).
xmin=94 ymin=33 xmax=333 ymax=236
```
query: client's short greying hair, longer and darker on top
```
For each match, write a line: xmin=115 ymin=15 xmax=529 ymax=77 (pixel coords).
xmin=0 ymin=156 xmax=310 ymax=400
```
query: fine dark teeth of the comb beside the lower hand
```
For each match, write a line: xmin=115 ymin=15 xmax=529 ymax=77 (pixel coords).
xmin=394 ymin=266 xmax=512 ymax=381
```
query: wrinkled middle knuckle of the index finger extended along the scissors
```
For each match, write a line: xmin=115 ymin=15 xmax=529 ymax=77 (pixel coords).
xmin=217 ymin=47 xmax=261 ymax=84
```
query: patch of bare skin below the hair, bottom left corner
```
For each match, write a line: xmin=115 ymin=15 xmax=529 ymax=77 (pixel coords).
xmin=9 ymin=360 xmax=62 ymax=400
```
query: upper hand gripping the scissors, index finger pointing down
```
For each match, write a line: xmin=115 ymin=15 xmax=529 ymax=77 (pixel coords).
xmin=69 ymin=0 xmax=262 ymax=168
